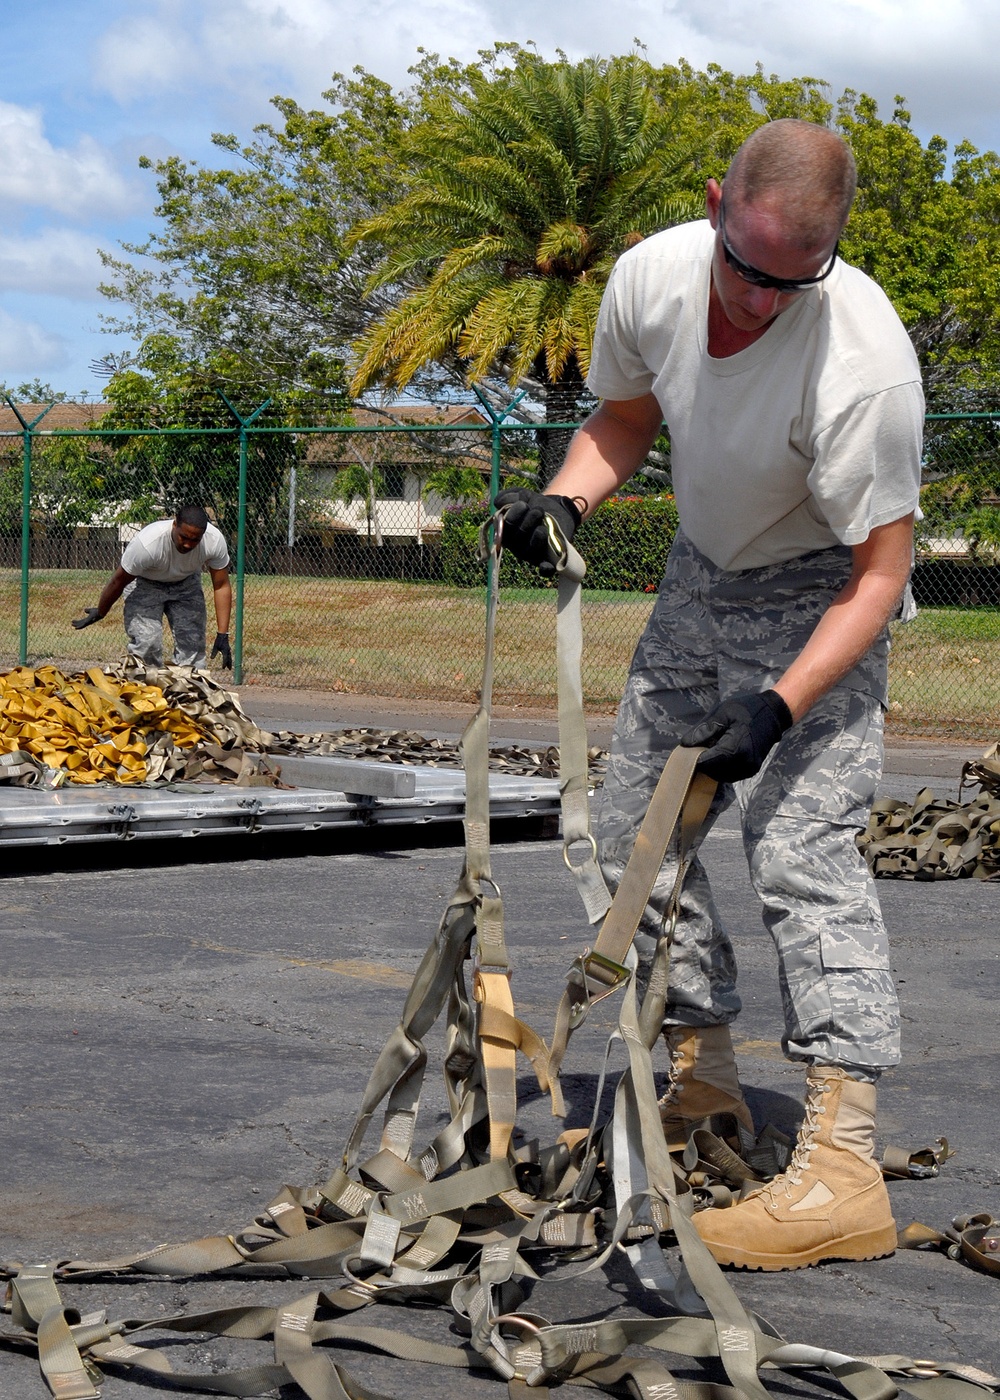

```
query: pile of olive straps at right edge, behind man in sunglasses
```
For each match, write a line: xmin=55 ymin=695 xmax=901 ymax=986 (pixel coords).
xmin=859 ymin=743 xmax=1000 ymax=879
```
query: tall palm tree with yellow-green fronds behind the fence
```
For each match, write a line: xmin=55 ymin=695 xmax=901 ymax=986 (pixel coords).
xmin=352 ymin=49 xmax=702 ymax=480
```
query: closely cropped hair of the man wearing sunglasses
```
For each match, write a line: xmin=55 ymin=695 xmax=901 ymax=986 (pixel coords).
xmin=724 ymin=118 xmax=857 ymax=248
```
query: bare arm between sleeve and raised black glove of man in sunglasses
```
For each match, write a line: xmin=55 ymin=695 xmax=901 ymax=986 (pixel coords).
xmin=546 ymin=395 xmax=662 ymax=517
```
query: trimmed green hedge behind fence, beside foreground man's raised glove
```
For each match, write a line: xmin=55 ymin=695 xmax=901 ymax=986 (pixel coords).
xmin=441 ymin=496 xmax=676 ymax=594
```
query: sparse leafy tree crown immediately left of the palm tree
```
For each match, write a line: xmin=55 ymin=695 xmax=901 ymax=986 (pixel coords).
xmin=101 ymin=71 xmax=413 ymax=412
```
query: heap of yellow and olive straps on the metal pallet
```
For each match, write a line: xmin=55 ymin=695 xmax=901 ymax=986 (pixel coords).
xmin=0 ymin=657 xmax=608 ymax=788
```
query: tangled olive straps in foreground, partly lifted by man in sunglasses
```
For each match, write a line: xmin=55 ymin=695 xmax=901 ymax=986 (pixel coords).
xmin=0 ymin=526 xmax=1000 ymax=1400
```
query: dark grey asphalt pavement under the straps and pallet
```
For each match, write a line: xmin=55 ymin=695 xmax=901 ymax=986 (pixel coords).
xmin=0 ymin=687 xmax=1000 ymax=1400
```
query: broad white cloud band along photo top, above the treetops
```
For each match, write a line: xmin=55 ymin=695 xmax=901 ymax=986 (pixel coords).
xmin=95 ymin=0 xmax=1000 ymax=154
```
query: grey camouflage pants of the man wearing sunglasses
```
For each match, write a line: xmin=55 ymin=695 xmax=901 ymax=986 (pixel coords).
xmin=598 ymin=535 xmax=899 ymax=1077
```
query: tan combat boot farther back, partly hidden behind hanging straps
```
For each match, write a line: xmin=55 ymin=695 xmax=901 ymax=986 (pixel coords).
xmin=660 ymin=1026 xmax=754 ymax=1152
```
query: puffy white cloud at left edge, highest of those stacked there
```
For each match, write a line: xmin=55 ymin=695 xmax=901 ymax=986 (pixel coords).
xmin=0 ymin=101 xmax=133 ymax=216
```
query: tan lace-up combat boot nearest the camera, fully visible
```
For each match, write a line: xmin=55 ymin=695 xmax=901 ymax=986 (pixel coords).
xmin=695 ymin=1064 xmax=896 ymax=1270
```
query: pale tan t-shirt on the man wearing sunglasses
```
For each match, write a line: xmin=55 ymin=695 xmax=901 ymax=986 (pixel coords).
xmin=587 ymin=220 xmax=924 ymax=570
